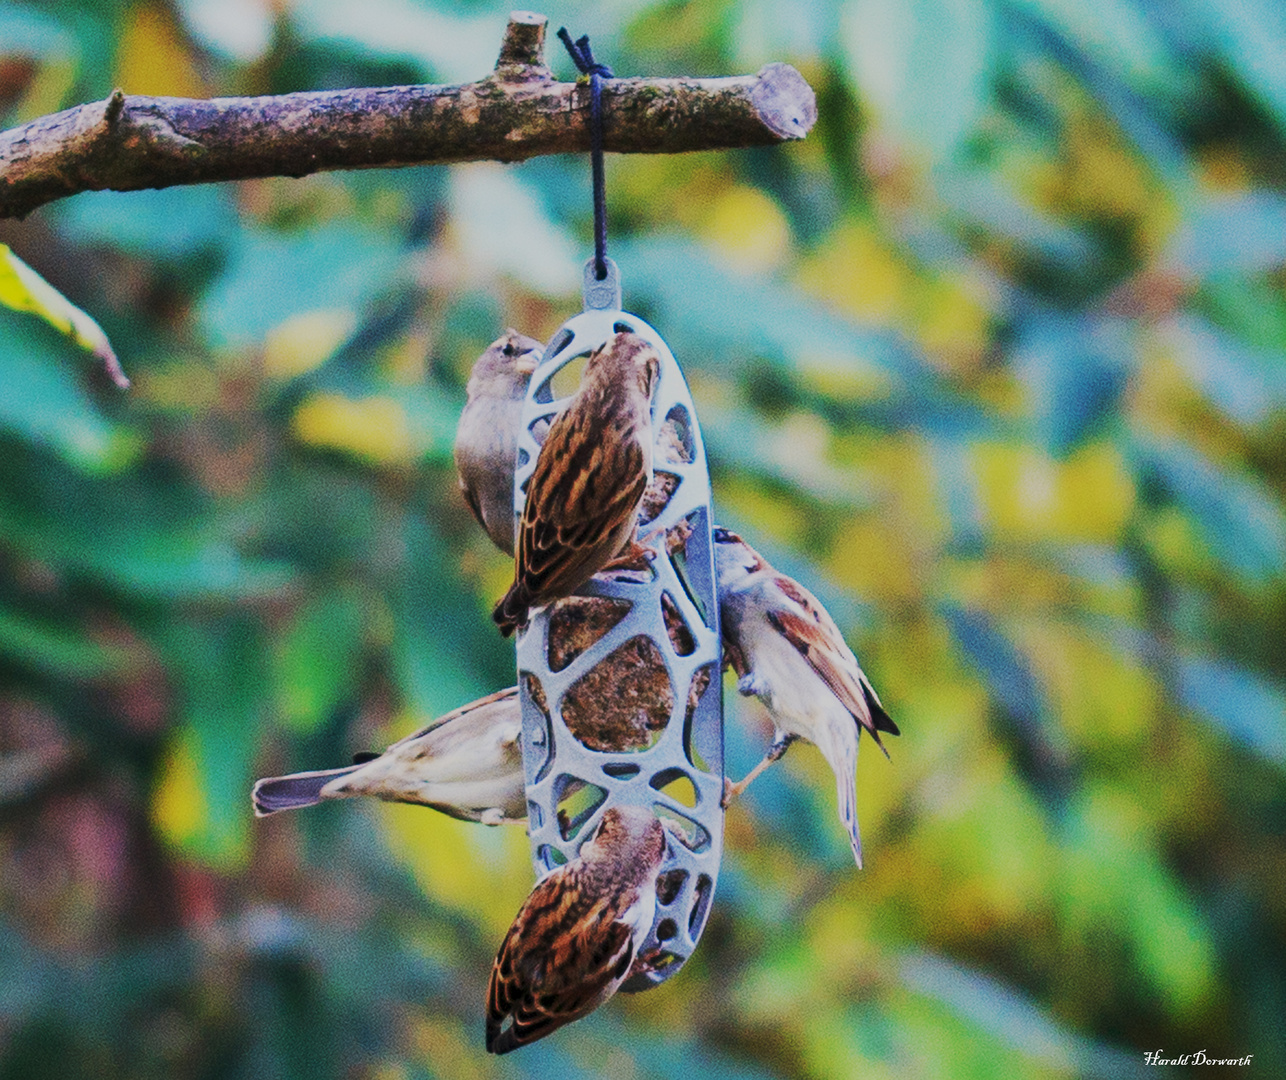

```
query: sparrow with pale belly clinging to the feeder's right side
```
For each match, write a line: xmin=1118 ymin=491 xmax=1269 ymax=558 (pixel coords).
xmin=714 ymin=528 xmax=900 ymax=869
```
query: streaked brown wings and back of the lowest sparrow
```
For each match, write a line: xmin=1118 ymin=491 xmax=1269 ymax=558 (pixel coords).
xmin=486 ymin=867 xmax=634 ymax=1054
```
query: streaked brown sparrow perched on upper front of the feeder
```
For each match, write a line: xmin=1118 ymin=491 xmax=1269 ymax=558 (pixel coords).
xmin=491 ymin=333 xmax=661 ymax=636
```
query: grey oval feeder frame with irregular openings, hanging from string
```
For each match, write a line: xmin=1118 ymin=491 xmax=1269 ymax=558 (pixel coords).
xmin=513 ymin=258 xmax=724 ymax=991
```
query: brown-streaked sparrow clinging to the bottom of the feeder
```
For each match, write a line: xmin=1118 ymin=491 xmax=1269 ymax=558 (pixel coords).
xmin=486 ymin=806 xmax=666 ymax=1054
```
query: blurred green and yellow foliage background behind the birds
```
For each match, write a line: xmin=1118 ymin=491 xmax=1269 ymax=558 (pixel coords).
xmin=0 ymin=0 xmax=1286 ymax=1080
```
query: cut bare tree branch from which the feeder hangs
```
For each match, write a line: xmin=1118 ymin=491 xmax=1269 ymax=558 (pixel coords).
xmin=0 ymin=12 xmax=817 ymax=217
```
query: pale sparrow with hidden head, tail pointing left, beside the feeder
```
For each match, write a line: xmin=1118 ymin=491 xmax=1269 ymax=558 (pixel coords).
xmin=251 ymin=687 xmax=527 ymax=825
